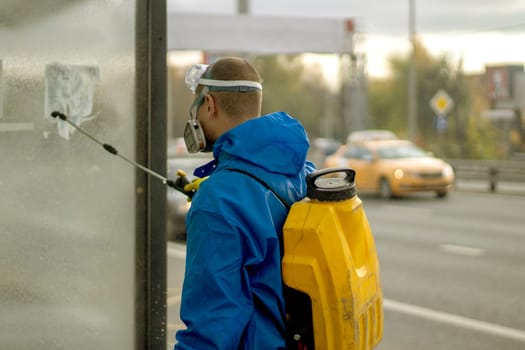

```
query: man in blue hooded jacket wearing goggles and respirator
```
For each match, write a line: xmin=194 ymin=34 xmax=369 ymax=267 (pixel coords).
xmin=175 ymin=58 xmax=314 ymax=350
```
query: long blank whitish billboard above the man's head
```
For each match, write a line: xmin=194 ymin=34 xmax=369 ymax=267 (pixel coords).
xmin=168 ymin=13 xmax=353 ymax=54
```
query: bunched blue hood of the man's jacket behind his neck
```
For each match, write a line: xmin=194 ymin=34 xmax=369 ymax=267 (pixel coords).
xmin=213 ymin=112 xmax=310 ymax=175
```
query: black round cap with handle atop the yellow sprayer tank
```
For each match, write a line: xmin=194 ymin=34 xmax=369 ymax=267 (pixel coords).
xmin=306 ymin=168 xmax=356 ymax=202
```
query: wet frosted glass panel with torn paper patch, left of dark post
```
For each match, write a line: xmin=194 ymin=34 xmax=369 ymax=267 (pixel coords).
xmin=0 ymin=0 xmax=135 ymax=350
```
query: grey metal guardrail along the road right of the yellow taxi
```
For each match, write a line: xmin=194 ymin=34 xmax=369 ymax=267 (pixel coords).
xmin=447 ymin=159 xmax=525 ymax=192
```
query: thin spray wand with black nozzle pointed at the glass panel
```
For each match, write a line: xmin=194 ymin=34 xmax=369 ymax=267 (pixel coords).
xmin=51 ymin=111 xmax=195 ymax=198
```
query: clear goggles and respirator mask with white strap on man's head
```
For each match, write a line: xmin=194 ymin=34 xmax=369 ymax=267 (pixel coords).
xmin=184 ymin=64 xmax=262 ymax=153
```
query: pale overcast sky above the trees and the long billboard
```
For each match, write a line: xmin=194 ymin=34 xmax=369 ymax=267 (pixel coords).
xmin=168 ymin=0 xmax=525 ymax=77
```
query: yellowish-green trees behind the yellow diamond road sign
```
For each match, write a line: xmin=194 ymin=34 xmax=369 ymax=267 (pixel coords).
xmin=368 ymin=43 xmax=501 ymax=159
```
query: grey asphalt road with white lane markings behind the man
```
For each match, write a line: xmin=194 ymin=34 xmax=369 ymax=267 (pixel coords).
xmin=168 ymin=192 xmax=525 ymax=350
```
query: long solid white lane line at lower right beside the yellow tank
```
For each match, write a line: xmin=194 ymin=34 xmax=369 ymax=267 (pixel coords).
xmin=383 ymin=299 xmax=525 ymax=342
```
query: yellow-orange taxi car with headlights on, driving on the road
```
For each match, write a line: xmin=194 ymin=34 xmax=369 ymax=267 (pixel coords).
xmin=324 ymin=139 xmax=454 ymax=198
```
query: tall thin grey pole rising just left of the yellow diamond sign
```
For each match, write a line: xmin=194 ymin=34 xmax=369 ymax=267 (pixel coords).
xmin=408 ymin=0 xmax=417 ymax=141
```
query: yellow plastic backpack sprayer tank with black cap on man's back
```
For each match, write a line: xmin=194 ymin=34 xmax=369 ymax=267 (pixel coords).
xmin=282 ymin=169 xmax=383 ymax=350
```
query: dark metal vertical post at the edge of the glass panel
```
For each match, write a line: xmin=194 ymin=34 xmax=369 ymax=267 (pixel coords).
xmin=135 ymin=0 xmax=167 ymax=350
